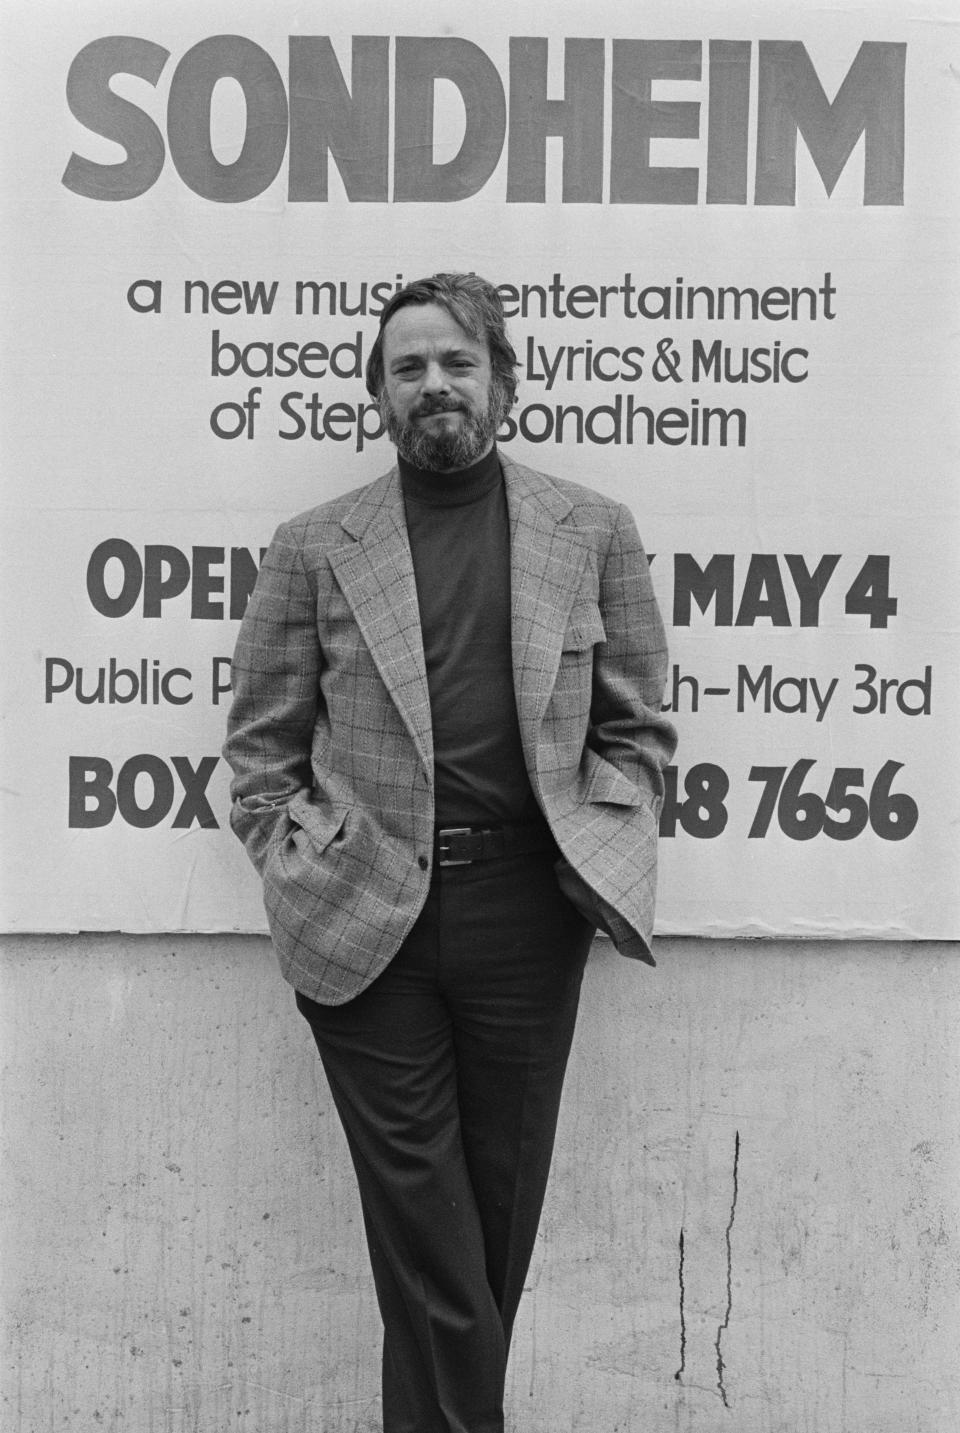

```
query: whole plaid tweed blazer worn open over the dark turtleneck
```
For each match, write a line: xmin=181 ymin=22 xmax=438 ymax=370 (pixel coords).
xmin=224 ymin=459 xmax=675 ymax=1005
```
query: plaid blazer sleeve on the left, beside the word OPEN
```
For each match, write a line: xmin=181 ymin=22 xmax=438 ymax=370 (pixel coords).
xmin=224 ymin=523 xmax=322 ymax=874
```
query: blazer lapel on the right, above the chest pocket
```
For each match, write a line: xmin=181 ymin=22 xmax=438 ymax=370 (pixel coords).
xmin=501 ymin=459 xmax=587 ymax=754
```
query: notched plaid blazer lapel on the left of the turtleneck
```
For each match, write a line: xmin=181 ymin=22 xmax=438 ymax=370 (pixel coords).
xmin=330 ymin=469 xmax=433 ymax=771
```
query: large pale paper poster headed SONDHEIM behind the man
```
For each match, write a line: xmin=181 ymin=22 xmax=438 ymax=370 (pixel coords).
xmin=0 ymin=0 xmax=960 ymax=937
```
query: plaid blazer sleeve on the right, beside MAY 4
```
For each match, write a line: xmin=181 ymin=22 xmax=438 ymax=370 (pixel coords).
xmin=587 ymin=506 xmax=676 ymax=818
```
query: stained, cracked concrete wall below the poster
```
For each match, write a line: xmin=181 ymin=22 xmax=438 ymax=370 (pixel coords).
xmin=0 ymin=936 xmax=960 ymax=1433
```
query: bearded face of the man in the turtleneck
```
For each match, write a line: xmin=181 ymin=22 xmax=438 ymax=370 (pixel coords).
xmin=380 ymin=304 xmax=503 ymax=473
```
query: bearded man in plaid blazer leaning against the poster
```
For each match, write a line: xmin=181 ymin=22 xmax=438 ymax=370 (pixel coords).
xmin=225 ymin=274 xmax=673 ymax=1433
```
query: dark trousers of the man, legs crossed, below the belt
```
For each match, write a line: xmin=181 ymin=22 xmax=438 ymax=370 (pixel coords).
xmin=297 ymin=851 xmax=593 ymax=1433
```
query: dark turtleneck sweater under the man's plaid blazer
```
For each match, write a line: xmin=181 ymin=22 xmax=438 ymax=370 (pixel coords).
xmin=400 ymin=449 xmax=537 ymax=825
